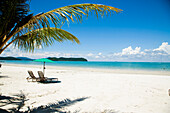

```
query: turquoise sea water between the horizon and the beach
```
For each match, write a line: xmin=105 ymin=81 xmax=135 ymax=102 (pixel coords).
xmin=2 ymin=60 xmax=170 ymax=71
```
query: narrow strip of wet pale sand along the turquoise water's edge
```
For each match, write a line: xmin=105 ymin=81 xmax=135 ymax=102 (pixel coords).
xmin=3 ymin=63 xmax=170 ymax=76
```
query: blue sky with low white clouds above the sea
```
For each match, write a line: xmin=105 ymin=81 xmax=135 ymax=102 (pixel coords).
xmin=3 ymin=0 xmax=170 ymax=62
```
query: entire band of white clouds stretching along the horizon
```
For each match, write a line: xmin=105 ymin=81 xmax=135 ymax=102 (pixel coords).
xmin=1 ymin=42 xmax=170 ymax=62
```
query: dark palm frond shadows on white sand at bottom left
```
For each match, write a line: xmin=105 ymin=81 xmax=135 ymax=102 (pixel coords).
xmin=0 ymin=92 xmax=89 ymax=113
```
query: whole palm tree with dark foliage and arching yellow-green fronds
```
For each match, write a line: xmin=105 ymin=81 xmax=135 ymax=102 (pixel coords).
xmin=0 ymin=0 xmax=122 ymax=54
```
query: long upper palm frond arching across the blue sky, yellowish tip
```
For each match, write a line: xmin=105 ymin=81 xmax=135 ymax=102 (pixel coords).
xmin=18 ymin=4 xmax=122 ymax=34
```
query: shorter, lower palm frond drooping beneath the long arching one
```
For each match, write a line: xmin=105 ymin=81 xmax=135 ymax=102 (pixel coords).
xmin=13 ymin=28 xmax=79 ymax=52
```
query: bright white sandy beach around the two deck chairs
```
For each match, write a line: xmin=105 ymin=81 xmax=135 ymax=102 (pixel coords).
xmin=0 ymin=64 xmax=170 ymax=113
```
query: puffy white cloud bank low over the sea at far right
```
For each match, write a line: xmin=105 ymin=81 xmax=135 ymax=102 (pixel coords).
xmin=108 ymin=42 xmax=170 ymax=62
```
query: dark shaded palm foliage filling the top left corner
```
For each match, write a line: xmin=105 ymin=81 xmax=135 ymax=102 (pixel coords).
xmin=0 ymin=0 xmax=29 ymax=40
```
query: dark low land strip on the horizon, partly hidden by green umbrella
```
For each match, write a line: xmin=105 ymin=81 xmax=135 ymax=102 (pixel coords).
xmin=0 ymin=57 xmax=87 ymax=62
